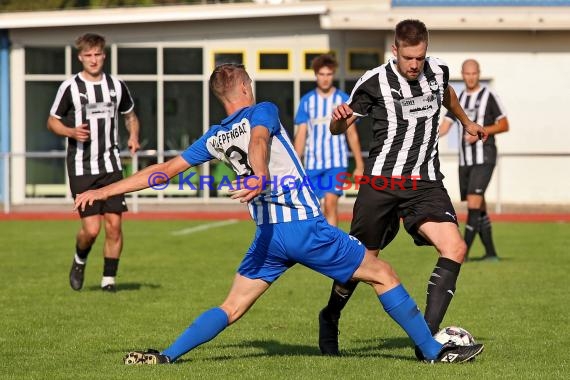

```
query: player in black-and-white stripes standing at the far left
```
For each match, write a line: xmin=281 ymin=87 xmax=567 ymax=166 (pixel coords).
xmin=47 ymin=33 xmax=140 ymax=292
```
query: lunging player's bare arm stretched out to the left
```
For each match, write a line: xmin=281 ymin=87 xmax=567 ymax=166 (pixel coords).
xmin=75 ymin=156 xmax=191 ymax=210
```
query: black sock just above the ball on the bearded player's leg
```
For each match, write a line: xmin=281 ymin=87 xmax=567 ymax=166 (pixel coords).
xmin=424 ymin=257 xmax=461 ymax=335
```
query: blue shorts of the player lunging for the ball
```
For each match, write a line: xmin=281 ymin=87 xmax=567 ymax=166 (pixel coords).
xmin=238 ymin=216 xmax=365 ymax=283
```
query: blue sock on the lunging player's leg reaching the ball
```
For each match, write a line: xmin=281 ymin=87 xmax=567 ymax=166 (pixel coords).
xmin=378 ymin=284 xmax=442 ymax=360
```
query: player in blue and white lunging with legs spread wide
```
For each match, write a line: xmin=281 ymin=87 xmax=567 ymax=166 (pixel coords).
xmin=75 ymin=64 xmax=483 ymax=364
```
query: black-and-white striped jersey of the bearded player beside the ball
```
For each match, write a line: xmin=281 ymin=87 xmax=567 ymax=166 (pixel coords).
xmin=347 ymin=57 xmax=449 ymax=182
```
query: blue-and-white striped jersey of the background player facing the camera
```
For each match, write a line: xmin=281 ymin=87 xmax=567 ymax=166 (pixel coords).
xmin=295 ymin=89 xmax=349 ymax=170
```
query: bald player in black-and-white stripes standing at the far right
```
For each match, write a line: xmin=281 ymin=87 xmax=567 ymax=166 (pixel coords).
xmin=439 ymin=59 xmax=509 ymax=260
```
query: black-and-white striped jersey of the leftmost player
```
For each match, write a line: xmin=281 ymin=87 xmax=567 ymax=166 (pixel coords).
xmin=50 ymin=74 xmax=134 ymax=176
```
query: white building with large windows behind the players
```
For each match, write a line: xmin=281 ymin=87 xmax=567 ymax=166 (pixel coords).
xmin=0 ymin=0 xmax=570 ymax=209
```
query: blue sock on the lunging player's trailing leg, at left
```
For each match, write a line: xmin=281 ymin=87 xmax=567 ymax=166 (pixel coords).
xmin=162 ymin=307 xmax=228 ymax=361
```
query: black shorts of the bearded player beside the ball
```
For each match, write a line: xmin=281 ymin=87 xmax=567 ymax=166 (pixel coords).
xmin=350 ymin=182 xmax=457 ymax=250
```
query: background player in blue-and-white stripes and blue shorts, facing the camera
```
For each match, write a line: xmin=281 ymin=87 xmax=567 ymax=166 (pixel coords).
xmin=295 ymin=54 xmax=364 ymax=226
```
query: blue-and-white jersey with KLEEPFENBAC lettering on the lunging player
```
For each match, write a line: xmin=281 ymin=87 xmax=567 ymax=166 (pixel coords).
xmin=182 ymin=102 xmax=321 ymax=225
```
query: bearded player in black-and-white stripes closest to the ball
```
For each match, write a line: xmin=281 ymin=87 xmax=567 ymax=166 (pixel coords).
xmin=319 ymin=20 xmax=486 ymax=358
